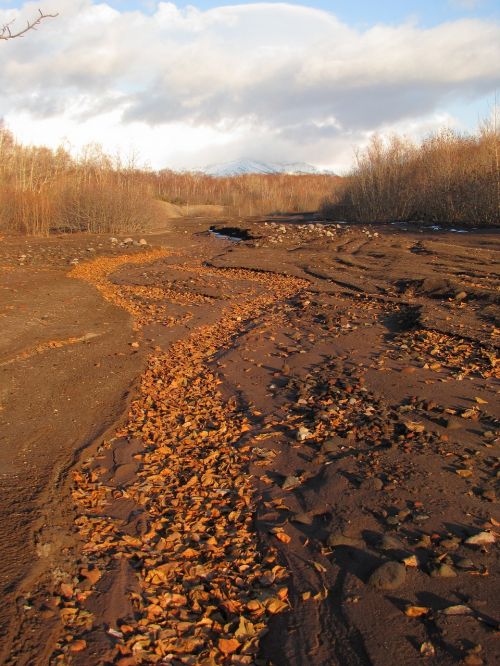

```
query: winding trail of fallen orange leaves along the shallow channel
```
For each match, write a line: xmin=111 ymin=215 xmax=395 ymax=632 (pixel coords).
xmin=52 ymin=251 xmax=309 ymax=666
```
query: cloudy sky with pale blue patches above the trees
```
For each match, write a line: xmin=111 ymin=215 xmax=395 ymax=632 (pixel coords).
xmin=0 ymin=0 xmax=500 ymax=173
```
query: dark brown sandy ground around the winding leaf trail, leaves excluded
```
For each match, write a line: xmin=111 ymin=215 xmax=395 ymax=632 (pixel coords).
xmin=0 ymin=219 xmax=500 ymax=666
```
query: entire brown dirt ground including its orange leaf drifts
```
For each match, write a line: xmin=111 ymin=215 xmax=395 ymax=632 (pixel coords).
xmin=0 ymin=216 xmax=500 ymax=666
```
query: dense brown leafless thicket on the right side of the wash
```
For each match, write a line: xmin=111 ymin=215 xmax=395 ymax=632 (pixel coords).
xmin=324 ymin=122 xmax=500 ymax=226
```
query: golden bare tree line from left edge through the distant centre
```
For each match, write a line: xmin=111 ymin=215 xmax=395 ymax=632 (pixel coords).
xmin=0 ymin=127 xmax=338 ymax=235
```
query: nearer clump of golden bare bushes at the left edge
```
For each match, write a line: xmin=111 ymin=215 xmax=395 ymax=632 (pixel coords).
xmin=0 ymin=129 xmax=158 ymax=235
